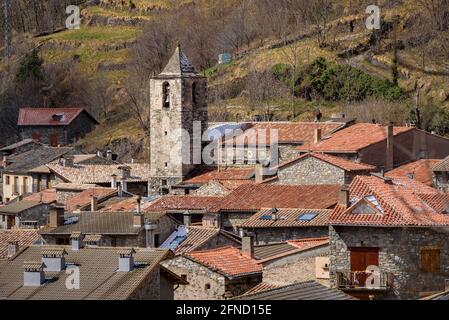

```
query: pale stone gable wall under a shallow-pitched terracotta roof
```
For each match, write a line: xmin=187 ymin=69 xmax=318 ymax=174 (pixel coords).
xmin=275 ymin=157 xmax=369 ymax=185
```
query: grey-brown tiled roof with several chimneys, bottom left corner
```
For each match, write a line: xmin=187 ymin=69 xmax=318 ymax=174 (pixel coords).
xmin=0 ymin=246 xmax=172 ymax=300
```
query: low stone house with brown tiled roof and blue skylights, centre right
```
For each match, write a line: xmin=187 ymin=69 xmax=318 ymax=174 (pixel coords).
xmin=239 ymin=208 xmax=332 ymax=245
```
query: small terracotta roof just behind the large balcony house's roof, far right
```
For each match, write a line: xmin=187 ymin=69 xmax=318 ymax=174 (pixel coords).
xmin=385 ymin=159 xmax=440 ymax=186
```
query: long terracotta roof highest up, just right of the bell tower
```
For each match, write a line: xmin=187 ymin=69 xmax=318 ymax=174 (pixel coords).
xmin=226 ymin=122 xmax=346 ymax=145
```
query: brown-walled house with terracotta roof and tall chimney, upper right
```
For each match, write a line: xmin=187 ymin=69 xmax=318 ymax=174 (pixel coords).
xmin=298 ymin=123 xmax=449 ymax=171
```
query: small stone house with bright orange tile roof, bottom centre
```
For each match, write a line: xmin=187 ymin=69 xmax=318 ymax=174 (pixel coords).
xmin=163 ymin=241 xmax=262 ymax=300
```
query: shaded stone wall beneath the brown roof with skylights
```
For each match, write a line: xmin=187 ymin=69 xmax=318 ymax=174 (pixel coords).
xmin=244 ymin=226 xmax=329 ymax=245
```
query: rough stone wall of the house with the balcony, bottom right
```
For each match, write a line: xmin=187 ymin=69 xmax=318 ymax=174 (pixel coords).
xmin=330 ymin=226 xmax=449 ymax=299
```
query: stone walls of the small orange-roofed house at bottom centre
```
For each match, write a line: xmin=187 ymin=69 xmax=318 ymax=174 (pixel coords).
xmin=162 ymin=256 xmax=262 ymax=300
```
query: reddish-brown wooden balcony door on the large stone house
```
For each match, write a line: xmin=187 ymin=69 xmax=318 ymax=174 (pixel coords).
xmin=349 ymin=248 xmax=379 ymax=287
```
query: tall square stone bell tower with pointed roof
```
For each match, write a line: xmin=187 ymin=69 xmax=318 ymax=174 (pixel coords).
xmin=149 ymin=45 xmax=208 ymax=194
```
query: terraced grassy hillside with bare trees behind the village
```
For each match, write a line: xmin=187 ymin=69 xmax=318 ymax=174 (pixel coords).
xmin=0 ymin=0 xmax=449 ymax=158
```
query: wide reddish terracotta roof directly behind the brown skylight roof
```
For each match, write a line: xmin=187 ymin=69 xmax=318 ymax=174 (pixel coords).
xmin=216 ymin=184 xmax=340 ymax=211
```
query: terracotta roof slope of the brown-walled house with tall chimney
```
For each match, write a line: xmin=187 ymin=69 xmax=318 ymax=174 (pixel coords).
xmin=298 ymin=123 xmax=414 ymax=153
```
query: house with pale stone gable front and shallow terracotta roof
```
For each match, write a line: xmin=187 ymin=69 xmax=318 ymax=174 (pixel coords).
xmin=272 ymin=153 xmax=377 ymax=185
